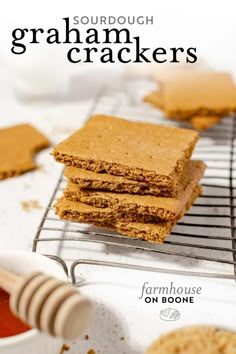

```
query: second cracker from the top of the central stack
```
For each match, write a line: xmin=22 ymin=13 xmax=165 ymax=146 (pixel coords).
xmin=64 ymin=166 xmax=178 ymax=197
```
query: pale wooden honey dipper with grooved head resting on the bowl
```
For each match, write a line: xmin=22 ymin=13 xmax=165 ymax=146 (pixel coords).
xmin=0 ymin=268 xmax=91 ymax=339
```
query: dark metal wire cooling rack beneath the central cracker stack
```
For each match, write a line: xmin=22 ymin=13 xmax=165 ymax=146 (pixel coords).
xmin=33 ymin=80 xmax=236 ymax=282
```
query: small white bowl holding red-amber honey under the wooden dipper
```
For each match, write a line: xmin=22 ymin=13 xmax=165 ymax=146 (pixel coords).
xmin=0 ymin=251 xmax=67 ymax=354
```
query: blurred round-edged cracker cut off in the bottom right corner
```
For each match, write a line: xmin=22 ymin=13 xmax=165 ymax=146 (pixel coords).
xmin=146 ymin=326 xmax=236 ymax=354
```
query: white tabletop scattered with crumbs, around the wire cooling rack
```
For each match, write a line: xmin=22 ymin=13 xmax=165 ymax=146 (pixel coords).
xmin=0 ymin=67 xmax=236 ymax=354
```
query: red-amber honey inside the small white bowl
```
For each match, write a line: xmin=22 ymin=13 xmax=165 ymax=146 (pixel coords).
xmin=0 ymin=288 xmax=31 ymax=338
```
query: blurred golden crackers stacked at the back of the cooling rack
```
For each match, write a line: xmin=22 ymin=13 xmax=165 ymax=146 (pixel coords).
xmin=144 ymin=70 xmax=236 ymax=130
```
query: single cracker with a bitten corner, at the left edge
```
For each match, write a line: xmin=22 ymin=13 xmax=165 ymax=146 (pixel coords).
xmin=0 ymin=124 xmax=49 ymax=180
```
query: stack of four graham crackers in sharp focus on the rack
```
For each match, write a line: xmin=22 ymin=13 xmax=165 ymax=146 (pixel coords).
xmin=52 ymin=115 xmax=205 ymax=243
